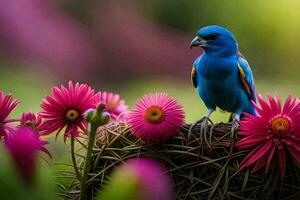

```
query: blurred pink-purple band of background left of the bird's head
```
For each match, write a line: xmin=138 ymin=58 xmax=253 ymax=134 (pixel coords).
xmin=0 ymin=0 xmax=200 ymax=84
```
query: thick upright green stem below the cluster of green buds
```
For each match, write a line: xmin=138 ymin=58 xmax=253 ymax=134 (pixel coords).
xmin=80 ymin=124 xmax=98 ymax=200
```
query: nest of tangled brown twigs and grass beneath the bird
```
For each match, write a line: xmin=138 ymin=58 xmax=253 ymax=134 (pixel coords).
xmin=63 ymin=123 xmax=300 ymax=200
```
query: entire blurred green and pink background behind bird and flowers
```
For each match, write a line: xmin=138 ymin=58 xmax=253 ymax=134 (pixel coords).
xmin=0 ymin=0 xmax=300 ymax=164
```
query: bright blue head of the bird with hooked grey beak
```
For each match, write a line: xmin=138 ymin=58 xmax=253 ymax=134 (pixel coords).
xmin=191 ymin=25 xmax=238 ymax=56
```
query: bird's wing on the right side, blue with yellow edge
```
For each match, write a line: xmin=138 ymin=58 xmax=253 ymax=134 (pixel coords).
xmin=238 ymin=55 xmax=256 ymax=102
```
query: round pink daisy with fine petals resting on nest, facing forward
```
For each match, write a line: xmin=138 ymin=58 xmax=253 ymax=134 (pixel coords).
xmin=127 ymin=93 xmax=184 ymax=142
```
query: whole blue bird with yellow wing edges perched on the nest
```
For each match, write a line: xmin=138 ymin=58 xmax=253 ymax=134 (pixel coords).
xmin=190 ymin=25 xmax=256 ymax=137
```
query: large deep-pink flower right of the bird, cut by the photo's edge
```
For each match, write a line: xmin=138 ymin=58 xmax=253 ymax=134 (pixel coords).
xmin=236 ymin=95 xmax=300 ymax=176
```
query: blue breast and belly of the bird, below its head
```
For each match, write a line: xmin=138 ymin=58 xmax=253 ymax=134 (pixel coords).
xmin=195 ymin=53 xmax=255 ymax=111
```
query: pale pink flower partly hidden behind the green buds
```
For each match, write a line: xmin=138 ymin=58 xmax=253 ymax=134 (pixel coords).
xmin=94 ymin=92 xmax=128 ymax=120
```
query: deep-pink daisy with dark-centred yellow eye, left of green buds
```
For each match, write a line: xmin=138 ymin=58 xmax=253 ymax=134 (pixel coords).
xmin=40 ymin=81 xmax=95 ymax=140
